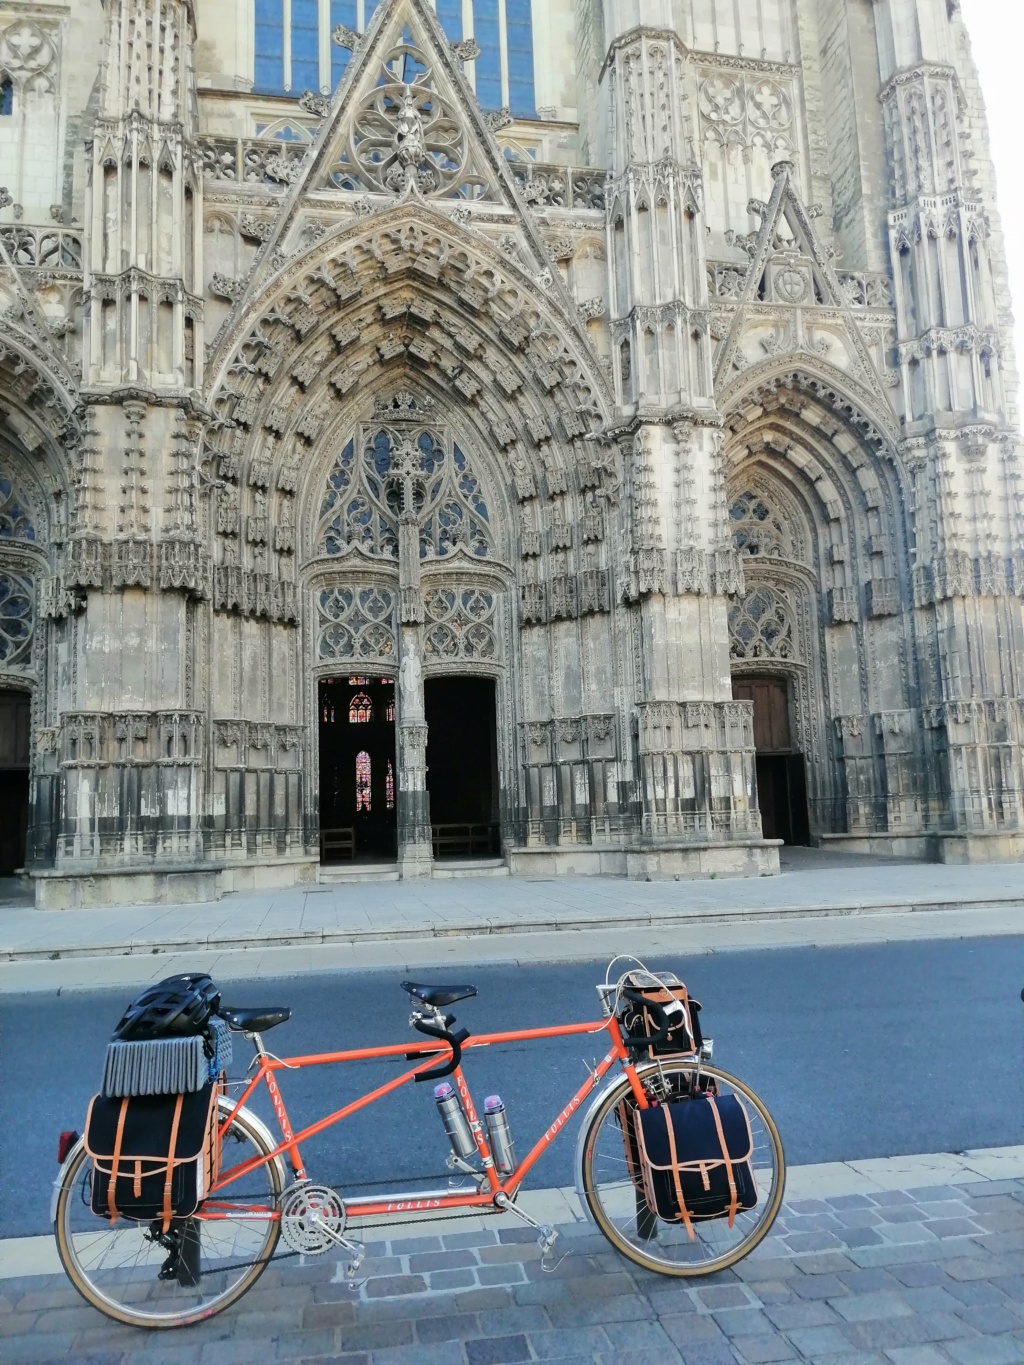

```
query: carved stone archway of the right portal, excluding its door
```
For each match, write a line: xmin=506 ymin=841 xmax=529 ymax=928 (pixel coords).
xmin=726 ymin=371 xmax=922 ymax=838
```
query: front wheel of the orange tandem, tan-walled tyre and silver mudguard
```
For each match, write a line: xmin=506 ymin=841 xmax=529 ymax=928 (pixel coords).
xmin=580 ymin=1061 xmax=785 ymax=1276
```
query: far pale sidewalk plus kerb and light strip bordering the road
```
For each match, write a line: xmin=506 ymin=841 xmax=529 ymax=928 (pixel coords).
xmin=0 ymin=849 xmax=1024 ymax=992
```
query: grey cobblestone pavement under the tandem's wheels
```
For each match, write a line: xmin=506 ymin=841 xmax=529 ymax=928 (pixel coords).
xmin=10 ymin=1179 xmax=1024 ymax=1365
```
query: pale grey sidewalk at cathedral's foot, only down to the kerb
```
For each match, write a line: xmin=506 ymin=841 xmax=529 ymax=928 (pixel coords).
xmin=0 ymin=854 xmax=1024 ymax=961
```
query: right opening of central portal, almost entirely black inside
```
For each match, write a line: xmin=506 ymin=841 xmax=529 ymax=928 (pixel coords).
xmin=423 ymin=677 xmax=501 ymax=859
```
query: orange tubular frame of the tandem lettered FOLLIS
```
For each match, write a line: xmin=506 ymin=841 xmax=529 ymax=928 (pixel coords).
xmin=204 ymin=1014 xmax=647 ymax=1219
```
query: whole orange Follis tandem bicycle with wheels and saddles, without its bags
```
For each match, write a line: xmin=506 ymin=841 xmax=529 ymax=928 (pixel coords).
xmin=52 ymin=960 xmax=785 ymax=1330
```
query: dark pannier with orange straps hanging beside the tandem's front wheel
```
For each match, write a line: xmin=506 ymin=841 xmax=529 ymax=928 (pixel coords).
xmin=631 ymin=1095 xmax=758 ymax=1241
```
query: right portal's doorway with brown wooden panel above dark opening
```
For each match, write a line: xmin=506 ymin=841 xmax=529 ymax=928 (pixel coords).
xmin=732 ymin=677 xmax=811 ymax=844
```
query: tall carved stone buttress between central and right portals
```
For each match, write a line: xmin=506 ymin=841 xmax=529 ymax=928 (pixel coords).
xmin=605 ymin=21 xmax=778 ymax=875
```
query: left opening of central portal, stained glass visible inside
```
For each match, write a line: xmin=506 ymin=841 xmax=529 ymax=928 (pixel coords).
xmin=319 ymin=673 xmax=399 ymax=863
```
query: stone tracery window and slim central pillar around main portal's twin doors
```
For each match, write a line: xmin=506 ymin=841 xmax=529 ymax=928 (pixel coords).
xmin=296 ymin=388 xmax=517 ymax=876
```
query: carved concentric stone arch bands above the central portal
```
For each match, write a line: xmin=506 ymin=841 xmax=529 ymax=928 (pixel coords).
xmin=208 ymin=206 xmax=610 ymax=529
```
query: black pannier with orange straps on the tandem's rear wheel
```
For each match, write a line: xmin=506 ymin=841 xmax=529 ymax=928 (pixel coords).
xmin=85 ymin=1081 xmax=220 ymax=1231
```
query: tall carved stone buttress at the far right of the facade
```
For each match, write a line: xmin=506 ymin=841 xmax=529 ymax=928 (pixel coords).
xmin=875 ymin=0 xmax=1024 ymax=861
